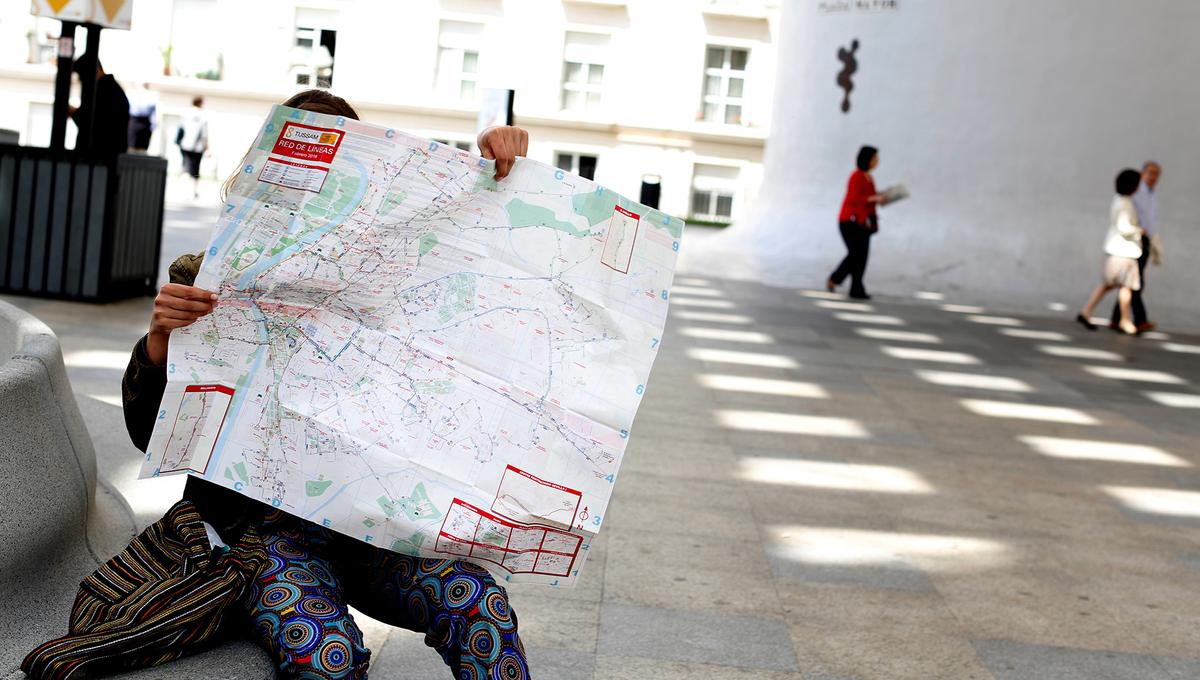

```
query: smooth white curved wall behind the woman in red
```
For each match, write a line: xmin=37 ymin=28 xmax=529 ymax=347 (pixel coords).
xmin=700 ymin=0 xmax=1200 ymax=327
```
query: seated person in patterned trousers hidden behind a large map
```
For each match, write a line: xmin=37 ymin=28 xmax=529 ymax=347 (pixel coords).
xmin=122 ymin=90 xmax=529 ymax=679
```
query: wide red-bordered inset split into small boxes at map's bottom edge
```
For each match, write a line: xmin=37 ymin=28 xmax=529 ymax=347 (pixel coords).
xmin=433 ymin=498 xmax=583 ymax=577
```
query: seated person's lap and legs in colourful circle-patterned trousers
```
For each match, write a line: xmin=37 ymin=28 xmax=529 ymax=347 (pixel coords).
xmin=247 ymin=514 xmax=529 ymax=680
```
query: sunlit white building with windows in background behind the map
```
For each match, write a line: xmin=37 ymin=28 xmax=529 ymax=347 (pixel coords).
xmin=0 ymin=0 xmax=779 ymax=229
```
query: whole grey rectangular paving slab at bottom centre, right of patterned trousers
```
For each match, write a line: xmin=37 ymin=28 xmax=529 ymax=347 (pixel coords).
xmin=599 ymin=602 xmax=799 ymax=670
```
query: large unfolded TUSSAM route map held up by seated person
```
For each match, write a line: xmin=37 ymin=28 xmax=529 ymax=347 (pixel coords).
xmin=142 ymin=107 xmax=683 ymax=585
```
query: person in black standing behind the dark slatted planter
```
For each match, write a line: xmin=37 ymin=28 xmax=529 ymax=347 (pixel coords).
xmin=67 ymin=53 xmax=130 ymax=157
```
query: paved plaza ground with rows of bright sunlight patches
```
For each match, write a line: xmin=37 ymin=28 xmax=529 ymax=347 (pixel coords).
xmin=6 ymin=194 xmax=1200 ymax=680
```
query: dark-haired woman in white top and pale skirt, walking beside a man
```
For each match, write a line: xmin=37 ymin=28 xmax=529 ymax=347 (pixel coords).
xmin=1075 ymin=169 xmax=1146 ymax=336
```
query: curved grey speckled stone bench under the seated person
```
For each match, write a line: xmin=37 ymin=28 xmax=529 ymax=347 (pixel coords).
xmin=0 ymin=301 xmax=275 ymax=680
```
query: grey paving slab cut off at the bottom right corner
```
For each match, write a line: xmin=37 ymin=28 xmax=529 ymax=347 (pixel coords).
xmin=974 ymin=640 xmax=1200 ymax=680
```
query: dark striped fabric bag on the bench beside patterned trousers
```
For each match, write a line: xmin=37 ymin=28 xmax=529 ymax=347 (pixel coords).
xmin=20 ymin=500 xmax=268 ymax=680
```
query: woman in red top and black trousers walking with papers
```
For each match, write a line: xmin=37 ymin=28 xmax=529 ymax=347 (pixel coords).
xmin=826 ymin=146 xmax=884 ymax=300
